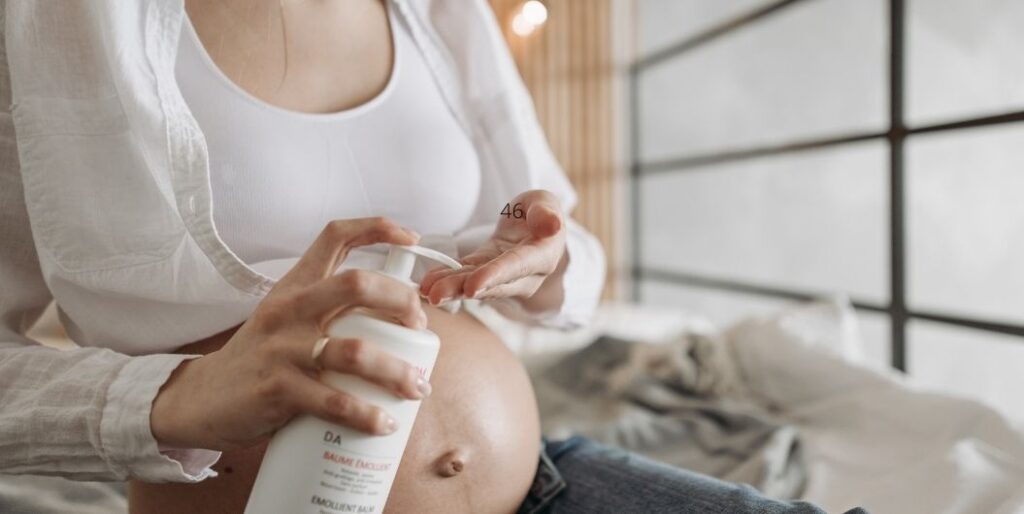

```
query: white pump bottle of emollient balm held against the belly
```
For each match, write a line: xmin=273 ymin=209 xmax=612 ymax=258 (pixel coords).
xmin=245 ymin=245 xmax=461 ymax=514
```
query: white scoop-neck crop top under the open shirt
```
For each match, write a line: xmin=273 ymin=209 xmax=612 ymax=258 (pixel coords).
xmin=175 ymin=5 xmax=480 ymax=264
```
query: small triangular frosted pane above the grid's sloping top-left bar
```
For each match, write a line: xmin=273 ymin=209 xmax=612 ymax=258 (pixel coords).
xmin=636 ymin=0 xmax=772 ymax=55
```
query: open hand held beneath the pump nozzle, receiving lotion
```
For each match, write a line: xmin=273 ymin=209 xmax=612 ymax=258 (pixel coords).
xmin=420 ymin=189 xmax=565 ymax=305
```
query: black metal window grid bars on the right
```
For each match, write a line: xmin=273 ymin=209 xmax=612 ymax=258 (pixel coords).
xmin=629 ymin=0 xmax=1024 ymax=371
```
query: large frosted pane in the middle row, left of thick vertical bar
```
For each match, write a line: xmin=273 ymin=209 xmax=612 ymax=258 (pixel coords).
xmin=640 ymin=141 xmax=889 ymax=303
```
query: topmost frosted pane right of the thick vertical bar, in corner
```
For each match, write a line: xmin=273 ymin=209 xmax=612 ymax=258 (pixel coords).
xmin=906 ymin=0 xmax=1024 ymax=125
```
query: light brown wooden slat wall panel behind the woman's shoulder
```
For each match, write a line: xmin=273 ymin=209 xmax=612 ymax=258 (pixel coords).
xmin=490 ymin=0 xmax=620 ymax=297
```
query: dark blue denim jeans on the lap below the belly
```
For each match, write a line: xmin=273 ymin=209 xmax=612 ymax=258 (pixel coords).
xmin=519 ymin=436 xmax=866 ymax=514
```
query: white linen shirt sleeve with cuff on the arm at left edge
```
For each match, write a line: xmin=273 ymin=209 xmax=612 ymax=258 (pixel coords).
xmin=0 ymin=30 xmax=220 ymax=482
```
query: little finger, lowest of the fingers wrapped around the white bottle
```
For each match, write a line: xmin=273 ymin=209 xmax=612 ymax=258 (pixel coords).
xmin=283 ymin=372 xmax=398 ymax=435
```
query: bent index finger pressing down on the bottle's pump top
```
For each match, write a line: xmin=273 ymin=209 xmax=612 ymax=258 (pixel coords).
xmin=281 ymin=217 xmax=420 ymax=286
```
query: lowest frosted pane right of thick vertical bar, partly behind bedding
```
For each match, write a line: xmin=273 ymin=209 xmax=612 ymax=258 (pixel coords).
xmin=907 ymin=320 xmax=1024 ymax=421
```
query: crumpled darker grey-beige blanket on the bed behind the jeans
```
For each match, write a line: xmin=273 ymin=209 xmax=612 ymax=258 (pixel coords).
xmin=532 ymin=334 xmax=807 ymax=499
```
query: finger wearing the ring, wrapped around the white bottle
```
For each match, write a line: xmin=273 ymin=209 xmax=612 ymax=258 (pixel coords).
xmin=317 ymin=339 xmax=430 ymax=399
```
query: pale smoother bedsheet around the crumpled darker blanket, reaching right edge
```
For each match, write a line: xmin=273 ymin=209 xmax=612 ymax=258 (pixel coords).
xmin=475 ymin=301 xmax=1024 ymax=514
